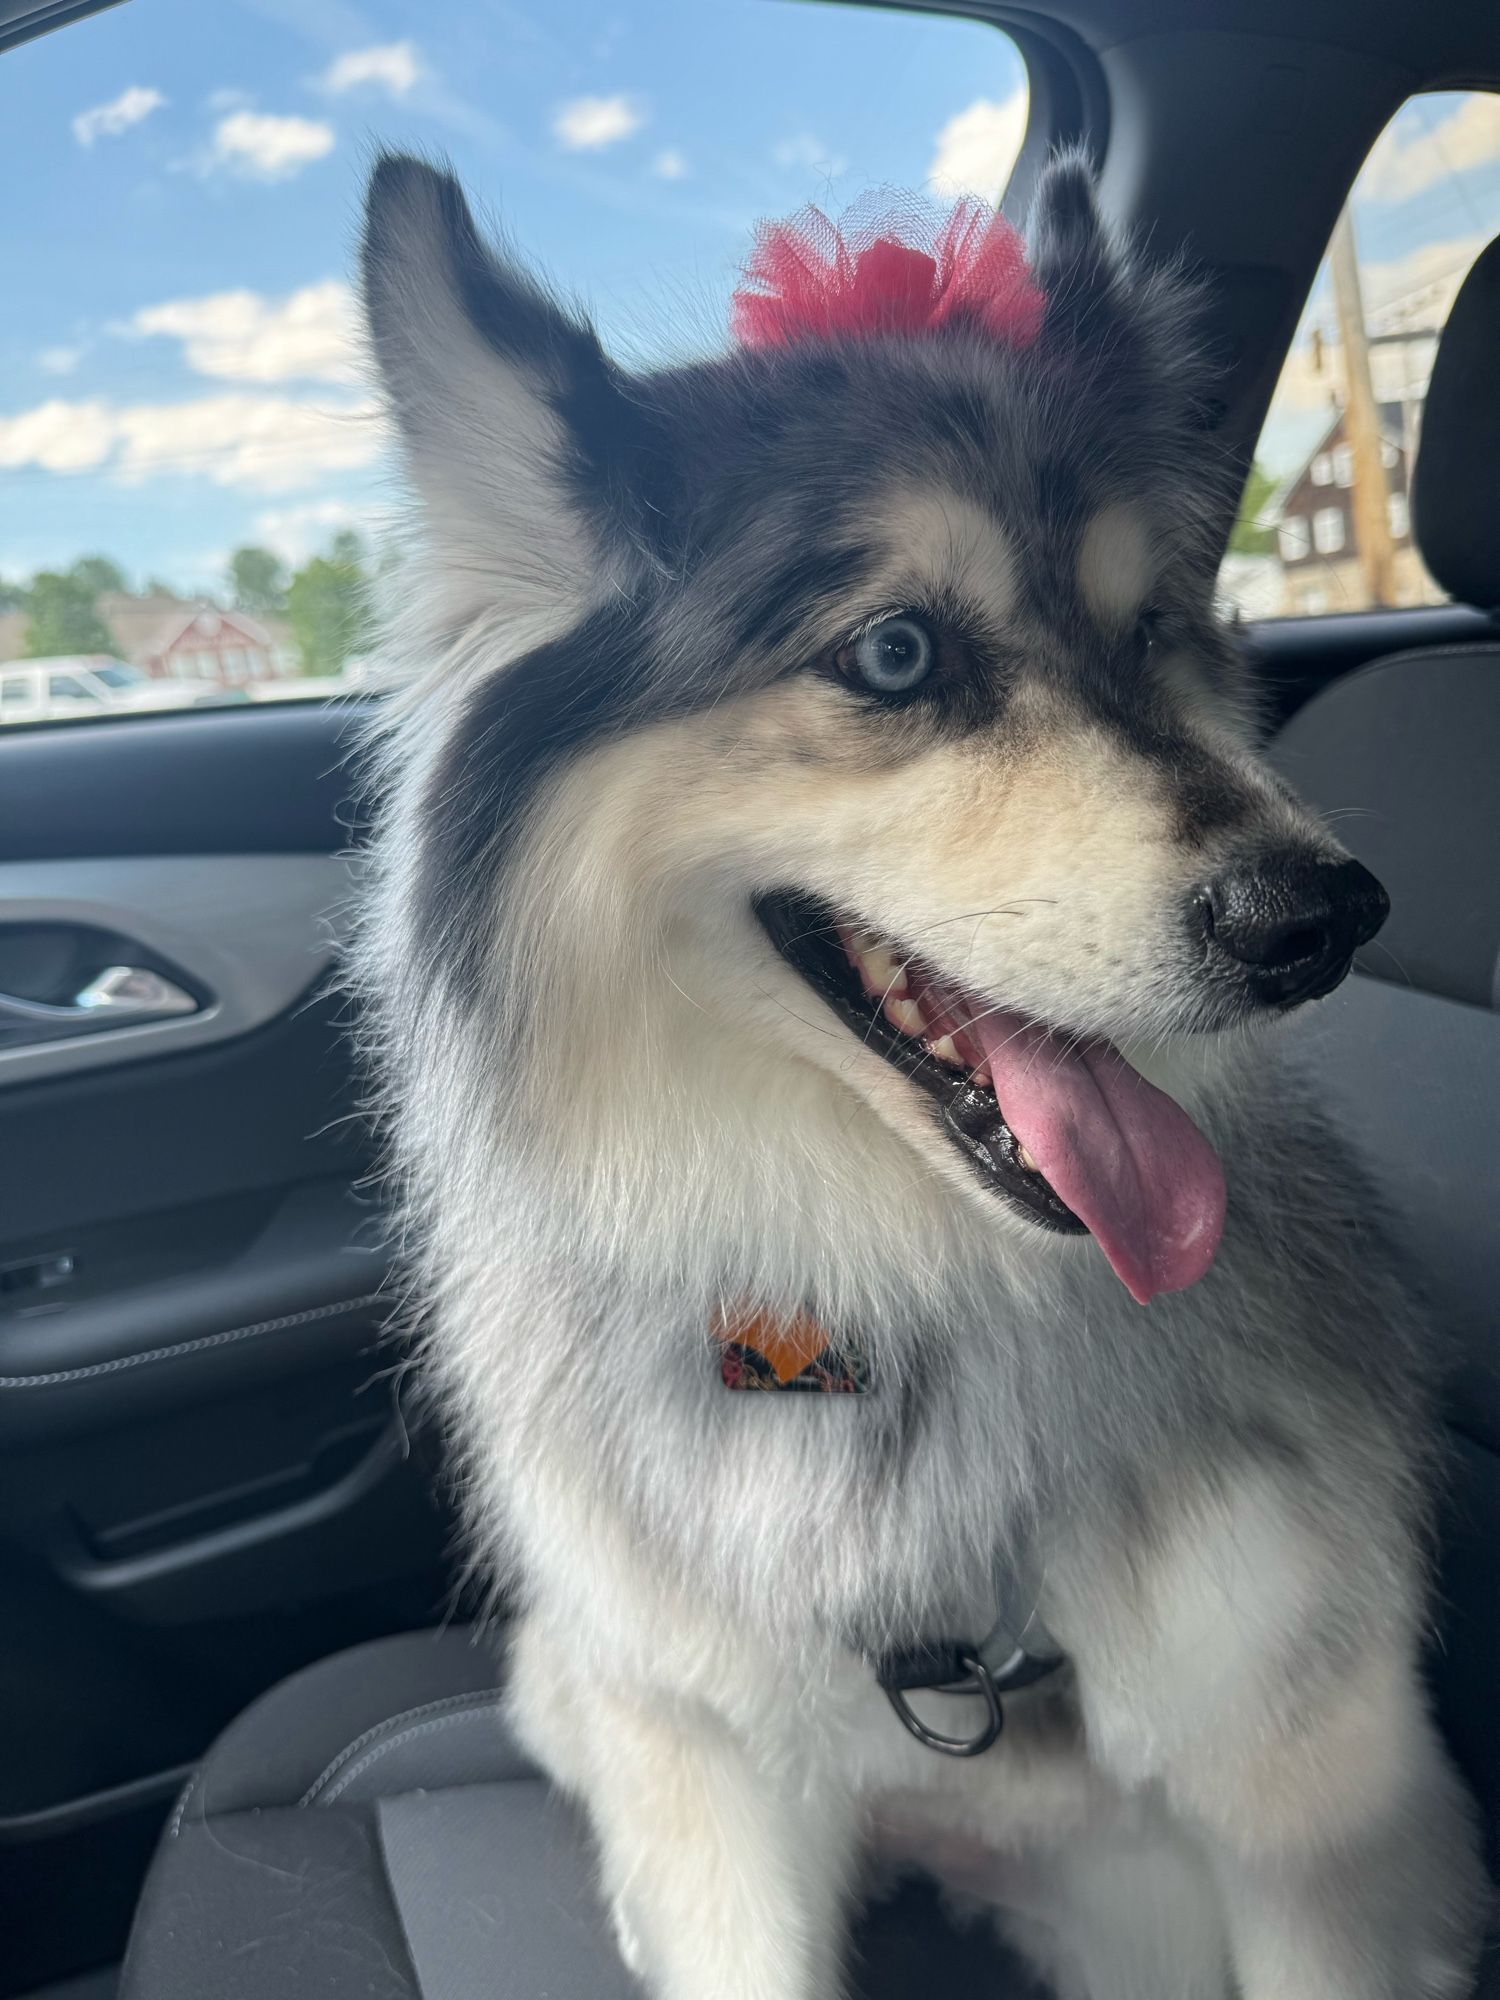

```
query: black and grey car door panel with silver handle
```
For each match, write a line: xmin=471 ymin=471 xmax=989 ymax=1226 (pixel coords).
xmin=0 ymin=702 xmax=452 ymax=1994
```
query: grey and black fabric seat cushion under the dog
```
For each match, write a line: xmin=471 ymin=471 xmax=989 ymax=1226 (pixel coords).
xmin=120 ymin=1630 xmax=1032 ymax=2000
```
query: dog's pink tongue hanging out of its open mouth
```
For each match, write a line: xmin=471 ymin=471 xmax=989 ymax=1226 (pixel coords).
xmin=970 ymin=1014 xmax=1224 ymax=1306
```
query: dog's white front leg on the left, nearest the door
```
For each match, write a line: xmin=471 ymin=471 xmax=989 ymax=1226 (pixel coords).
xmin=512 ymin=1622 xmax=856 ymax=2000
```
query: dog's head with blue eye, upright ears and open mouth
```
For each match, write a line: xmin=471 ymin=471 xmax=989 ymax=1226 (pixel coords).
xmin=364 ymin=160 xmax=1384 ymax=1298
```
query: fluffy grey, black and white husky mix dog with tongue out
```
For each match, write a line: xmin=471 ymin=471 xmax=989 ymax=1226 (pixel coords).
xmin=356 ymin=158 xmax=1482 ymax=2000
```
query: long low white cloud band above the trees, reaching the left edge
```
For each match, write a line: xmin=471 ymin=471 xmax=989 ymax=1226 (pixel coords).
xmin=0 ymin=392 xmax=384 ymax=494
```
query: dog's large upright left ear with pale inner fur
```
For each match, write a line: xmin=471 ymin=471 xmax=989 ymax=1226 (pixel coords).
xmin=360 ymin=154 xmax=660 ymax=610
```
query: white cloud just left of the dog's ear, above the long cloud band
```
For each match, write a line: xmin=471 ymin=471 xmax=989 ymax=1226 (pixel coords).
xmin=114 ymin=278 xmax=360 ymax=382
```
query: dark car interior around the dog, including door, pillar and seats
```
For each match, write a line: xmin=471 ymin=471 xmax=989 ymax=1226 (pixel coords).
xmin=0 ymin=0 xmax=1500 ymax=2000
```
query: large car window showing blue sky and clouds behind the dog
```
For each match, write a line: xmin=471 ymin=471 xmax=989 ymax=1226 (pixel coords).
xmin=0 ymin=0 xmax=1028 ymax=718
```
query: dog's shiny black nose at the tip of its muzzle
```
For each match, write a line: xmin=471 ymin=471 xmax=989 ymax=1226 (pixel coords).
xmin=1198 ymin=848 xmax=1390 ymax=1006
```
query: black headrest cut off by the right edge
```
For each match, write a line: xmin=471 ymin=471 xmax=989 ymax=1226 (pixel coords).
xmin=1412 ymin=236 xmax=1500 ymax=612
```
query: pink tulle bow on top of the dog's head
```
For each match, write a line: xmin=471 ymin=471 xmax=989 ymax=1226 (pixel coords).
xmin=730 ymin=200 xmax=1046 ymax=348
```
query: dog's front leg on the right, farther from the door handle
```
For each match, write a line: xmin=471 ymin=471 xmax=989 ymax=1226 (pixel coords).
xmin=1054 ymin=1472 xmax=1484 ymax=2000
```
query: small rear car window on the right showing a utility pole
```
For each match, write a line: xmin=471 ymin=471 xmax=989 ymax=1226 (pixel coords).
xmin=1220 ymin=90 xmax=1500 ymax=618
